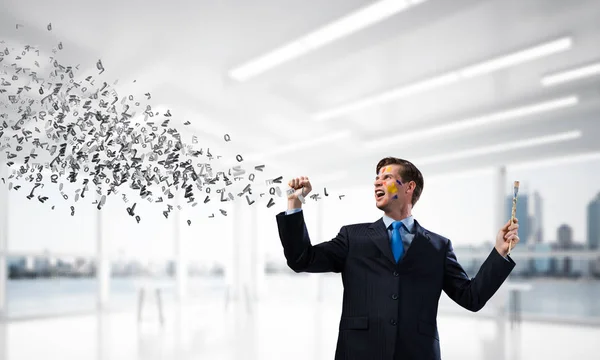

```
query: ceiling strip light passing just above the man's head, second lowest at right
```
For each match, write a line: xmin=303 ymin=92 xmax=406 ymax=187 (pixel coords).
xmin=365 ymin=96 xmax=579 ymax=149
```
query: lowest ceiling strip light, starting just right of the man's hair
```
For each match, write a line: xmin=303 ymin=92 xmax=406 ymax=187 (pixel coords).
xmin=415 ymin=130 xmax=582 ymax=165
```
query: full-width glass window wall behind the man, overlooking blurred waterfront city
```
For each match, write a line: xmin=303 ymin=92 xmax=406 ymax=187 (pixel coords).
xmin=7 ymin=156 xmax=600 ymax=318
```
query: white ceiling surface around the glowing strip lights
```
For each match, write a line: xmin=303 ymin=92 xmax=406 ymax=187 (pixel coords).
xmin=0 ymin=0 xmax=600 ymax=184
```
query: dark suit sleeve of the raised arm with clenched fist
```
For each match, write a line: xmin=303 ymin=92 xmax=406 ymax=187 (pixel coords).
xmin=276 ymin=211 xmax=348 ymax=273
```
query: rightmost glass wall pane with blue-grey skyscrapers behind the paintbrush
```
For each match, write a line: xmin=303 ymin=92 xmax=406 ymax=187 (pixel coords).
xmin=507 ymin=157 xmax=600 ymax=319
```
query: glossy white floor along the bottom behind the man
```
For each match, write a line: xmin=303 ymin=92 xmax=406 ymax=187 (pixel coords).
xmin=0 ymin=300 xmax=600 ymax=360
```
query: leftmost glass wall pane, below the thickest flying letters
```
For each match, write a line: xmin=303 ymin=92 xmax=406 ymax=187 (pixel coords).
xmin=4 ymin=165 xmax=98 ymax=318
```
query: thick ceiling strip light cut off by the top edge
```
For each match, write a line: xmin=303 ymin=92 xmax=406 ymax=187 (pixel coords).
xmin=229 ymin=0 xmax=426 ymax=81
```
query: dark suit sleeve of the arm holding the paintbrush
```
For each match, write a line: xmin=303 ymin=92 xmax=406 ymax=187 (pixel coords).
xmin=443 ymin=240 xmax=515 ymax=311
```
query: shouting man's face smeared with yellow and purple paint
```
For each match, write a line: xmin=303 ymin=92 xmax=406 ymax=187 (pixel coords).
xmin=374 ymin=164 xmax=406 ymax=211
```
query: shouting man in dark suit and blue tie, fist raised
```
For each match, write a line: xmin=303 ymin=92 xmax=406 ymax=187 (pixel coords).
xmin=276 ymin=157 xmax=519 ymax=360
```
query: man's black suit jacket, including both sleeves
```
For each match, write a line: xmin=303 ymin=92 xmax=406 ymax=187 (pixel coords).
xmin=276 ymin=212 xmax=515 ymax=360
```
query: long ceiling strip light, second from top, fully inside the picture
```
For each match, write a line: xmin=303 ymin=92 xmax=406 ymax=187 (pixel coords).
xmin=313 ymin=38 xmax=573 ymax=121
